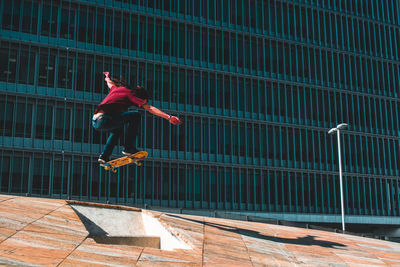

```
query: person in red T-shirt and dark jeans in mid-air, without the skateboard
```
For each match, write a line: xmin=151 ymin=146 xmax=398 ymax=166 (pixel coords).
xmin=92 ymin=72 xmax=182 ymax=164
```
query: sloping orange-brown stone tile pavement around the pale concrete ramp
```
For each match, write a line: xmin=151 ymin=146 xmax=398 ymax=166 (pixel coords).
xmin=0 ymin=195 xmax=400 ymax=266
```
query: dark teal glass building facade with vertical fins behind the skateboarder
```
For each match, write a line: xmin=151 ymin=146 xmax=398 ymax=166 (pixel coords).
xmin=0 ymin=0 xmax=400 ymax=222
